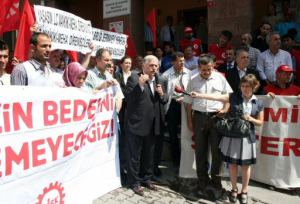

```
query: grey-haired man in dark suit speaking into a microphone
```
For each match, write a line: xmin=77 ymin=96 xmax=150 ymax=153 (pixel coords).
xmin=125 ymin=55 xmax=167 ymax=196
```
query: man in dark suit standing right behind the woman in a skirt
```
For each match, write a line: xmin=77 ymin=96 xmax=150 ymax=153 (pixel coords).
xmin=226 ymin=48 xmax=263 ymax=95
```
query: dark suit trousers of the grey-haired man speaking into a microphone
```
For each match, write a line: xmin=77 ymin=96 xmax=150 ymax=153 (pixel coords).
xmin=126 ymin=132 xmax=155 ymax=187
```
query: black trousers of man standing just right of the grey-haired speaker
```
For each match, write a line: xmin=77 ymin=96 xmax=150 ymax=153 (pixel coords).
xmin=167 ymin=100 xmax=181 ymax=166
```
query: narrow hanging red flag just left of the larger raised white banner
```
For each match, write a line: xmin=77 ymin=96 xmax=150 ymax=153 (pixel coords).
xmin=14 ymin=0 xmax=35 ymax=61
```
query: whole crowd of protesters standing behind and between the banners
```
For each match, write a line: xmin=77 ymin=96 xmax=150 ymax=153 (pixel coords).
xmin=0 ymin=3 xmax=300 ymax=203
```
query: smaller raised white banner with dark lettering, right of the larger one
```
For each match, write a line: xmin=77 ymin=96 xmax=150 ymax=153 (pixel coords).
xmin=93 ymin=28 xmax=127 ymax=59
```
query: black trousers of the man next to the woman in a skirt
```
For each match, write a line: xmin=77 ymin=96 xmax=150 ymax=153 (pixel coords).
xmin=193 ymin=111 xmax=222 ymax=188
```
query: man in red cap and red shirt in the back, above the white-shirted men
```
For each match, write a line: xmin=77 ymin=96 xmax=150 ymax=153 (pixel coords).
xmin=179 ymin=27 xmax=202 ymax=56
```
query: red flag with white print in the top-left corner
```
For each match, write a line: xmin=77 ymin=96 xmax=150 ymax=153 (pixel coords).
xmin=0 ymin=0 xmax=20 ymax=35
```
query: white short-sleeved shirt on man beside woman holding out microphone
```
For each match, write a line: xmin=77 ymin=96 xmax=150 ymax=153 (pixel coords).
xmin=184 ymin=71 xmax=232 ymax=112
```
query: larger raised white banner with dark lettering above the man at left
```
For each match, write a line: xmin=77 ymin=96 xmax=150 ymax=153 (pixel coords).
xmin=34 ymin=5 xmax=93 ymax=53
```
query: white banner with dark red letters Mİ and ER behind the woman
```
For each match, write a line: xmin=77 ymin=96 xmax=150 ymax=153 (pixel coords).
xmin=179 ymin=96 xmax=300 ymax=188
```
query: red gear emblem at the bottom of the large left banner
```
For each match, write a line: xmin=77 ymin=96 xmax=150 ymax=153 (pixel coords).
xmin=37 ymin=181 xmax=65 ymax=204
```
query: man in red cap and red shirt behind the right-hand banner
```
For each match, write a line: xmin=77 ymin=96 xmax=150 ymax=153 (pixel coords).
xmin=264 ymin=65 xmax=300 ymax=98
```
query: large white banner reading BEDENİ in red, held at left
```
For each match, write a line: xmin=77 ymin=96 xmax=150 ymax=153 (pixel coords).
xmin=0 ymin=86 xmax=120 ymax=204
